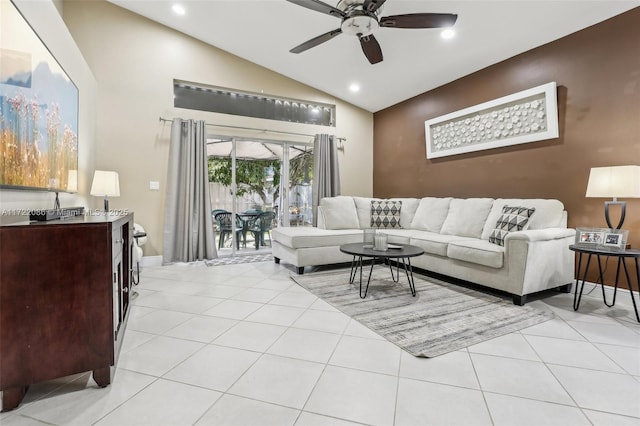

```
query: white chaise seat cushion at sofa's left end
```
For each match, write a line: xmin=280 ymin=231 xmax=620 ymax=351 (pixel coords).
xmin=271 ymin=226 xmax=363 ymax=249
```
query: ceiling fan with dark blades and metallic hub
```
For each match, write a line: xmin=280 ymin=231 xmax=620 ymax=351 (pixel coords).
xmin=287 ymin=0 xmax=458 ymax=64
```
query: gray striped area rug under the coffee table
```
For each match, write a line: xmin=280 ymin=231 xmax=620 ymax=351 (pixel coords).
xmin=291 ymin=266 xmax=554 ymax=358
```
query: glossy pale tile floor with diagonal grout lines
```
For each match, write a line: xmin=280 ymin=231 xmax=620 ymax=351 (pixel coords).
xmin=0 ymin=262 xmax=640 ymax=426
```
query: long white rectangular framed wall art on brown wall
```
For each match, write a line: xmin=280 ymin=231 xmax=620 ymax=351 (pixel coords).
xmin=424 ymin=82 xmax=559 ymax=159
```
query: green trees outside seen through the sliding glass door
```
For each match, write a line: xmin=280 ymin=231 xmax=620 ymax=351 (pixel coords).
xmin=209 ymin=152 xmax=313 ymax=205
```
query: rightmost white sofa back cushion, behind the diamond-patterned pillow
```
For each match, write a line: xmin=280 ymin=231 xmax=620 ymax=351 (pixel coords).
xmin=481 ymin=198 xmax=566 ymax=240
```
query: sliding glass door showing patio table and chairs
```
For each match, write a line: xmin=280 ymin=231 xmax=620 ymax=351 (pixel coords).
xmin=208 ymin=137 xmax=313 ymax=255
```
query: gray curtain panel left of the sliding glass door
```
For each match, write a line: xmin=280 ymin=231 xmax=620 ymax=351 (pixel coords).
xmin=163 ymin=118 xmax=218 ymax=263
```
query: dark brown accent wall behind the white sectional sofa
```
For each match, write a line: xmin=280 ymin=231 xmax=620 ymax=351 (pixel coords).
xmin=373 ymin=8 xmax=640 ymax=288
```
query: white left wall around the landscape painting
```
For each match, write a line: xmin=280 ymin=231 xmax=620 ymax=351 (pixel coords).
xmin=0 ymin=0 xmax=96 ymax=219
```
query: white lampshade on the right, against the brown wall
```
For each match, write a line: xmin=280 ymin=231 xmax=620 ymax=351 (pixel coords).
xmin=586 ymin=166 xmax=640 ymax=198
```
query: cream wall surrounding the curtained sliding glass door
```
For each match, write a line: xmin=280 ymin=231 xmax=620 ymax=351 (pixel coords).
xmin=63 ymin=0 xmax=373 ymax=256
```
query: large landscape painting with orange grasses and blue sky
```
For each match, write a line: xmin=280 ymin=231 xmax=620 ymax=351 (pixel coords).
xmin=0 ymin=1 xmax=78 ymax=191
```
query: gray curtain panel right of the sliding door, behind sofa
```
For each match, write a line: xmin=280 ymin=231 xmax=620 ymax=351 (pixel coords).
xmin=312 ymin=134 xmax=340 ymax=226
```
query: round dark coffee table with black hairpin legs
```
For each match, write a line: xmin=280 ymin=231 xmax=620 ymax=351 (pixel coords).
xmin=340 ymin=243 xmax=424 ymax=299
